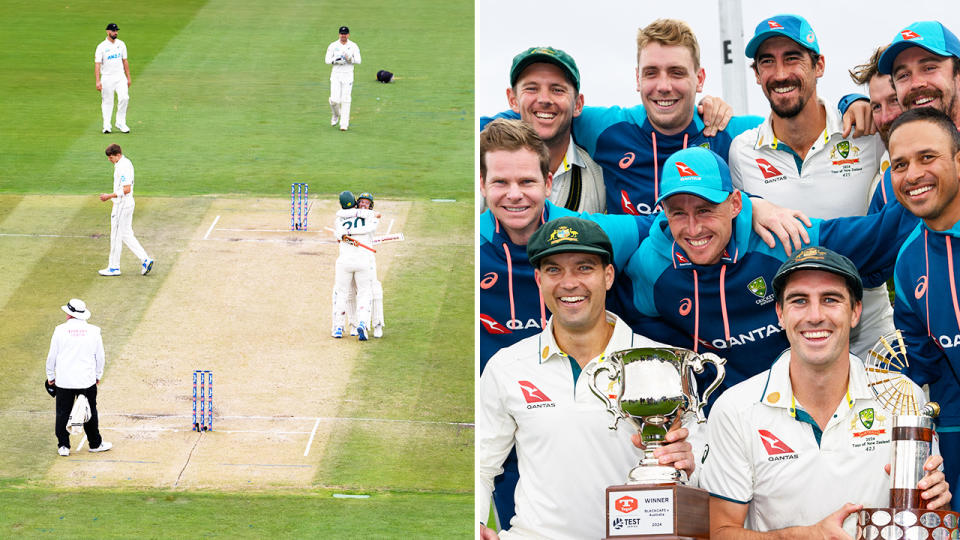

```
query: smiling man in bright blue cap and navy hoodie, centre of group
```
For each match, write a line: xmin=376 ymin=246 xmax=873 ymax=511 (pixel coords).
xmin=624 ymin=147 xmax=916 ymax=394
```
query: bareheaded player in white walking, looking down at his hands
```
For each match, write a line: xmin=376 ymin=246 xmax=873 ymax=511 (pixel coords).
xmin=100 ymin=144 xmax=153 ymax=276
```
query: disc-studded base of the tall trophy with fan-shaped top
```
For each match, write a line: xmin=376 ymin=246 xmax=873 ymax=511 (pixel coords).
xmin=855 ymin=508 xmax=960 ymax=540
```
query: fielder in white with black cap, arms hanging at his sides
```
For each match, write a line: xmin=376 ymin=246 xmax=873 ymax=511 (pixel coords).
xmin=93 ymin=23 xmax=131 ymax=133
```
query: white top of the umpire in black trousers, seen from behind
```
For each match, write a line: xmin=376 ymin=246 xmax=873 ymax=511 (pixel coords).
xmin=47 ymin=319 xmax=104 ymax=388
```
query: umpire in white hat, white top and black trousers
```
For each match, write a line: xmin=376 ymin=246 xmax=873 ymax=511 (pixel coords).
xmin=47 ymin=298 xmax=113 ymax=456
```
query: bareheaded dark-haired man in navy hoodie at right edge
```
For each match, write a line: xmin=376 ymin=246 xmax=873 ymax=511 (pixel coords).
xmin=890 ymin=107 xmax=960 ymax=502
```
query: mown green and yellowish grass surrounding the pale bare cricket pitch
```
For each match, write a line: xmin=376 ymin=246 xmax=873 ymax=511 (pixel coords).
xmin=0 ymin=0 xmax=474 ymax=538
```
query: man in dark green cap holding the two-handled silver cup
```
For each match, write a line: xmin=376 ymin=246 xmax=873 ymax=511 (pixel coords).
xmin=476 ymin=217 xmax=695 ymax=539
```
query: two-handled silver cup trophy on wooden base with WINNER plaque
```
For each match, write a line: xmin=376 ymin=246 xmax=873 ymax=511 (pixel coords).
xmin=585 ymin=348 xmax=725 ymax=540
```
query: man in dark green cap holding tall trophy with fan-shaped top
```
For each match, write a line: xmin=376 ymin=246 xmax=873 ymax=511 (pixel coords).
xmin=700 ymin=247 xmax=951 ymax=539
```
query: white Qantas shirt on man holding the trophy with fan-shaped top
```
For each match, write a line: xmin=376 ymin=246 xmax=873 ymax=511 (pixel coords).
xmin=700 ymin=349 xmax=939 ymax=536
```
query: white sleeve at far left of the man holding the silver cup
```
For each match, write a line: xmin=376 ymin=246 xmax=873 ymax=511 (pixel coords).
xmin=474 ymin=352 xmax=517 ymax=523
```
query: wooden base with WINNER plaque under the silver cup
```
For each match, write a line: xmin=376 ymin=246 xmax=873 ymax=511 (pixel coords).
xmin=606 ymin=484 xmax=710 ymax=540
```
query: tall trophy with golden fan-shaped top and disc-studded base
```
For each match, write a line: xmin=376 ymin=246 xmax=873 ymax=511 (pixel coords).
xmin=857 ymin=330 xmax=960 ymax=540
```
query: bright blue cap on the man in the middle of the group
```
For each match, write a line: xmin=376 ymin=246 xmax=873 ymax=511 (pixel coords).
xmin=657 ymin=146 xmax=733 ymax=204
